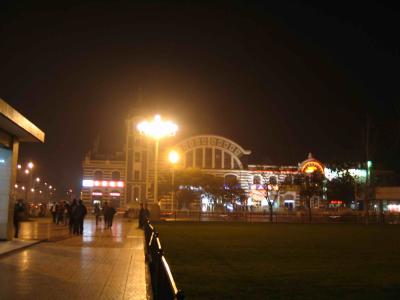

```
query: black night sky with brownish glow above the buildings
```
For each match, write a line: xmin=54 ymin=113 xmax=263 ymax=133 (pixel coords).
xmin=0 ymin=0 xmax=400 ymax=195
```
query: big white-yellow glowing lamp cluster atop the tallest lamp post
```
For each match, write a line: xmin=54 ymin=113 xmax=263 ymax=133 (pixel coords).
xmin=137 ymin=115 xmax=178 ymax=140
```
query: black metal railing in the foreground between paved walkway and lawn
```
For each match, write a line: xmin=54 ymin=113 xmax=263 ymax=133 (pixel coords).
xmin=143 ymin=220 xmax=185 ymax=300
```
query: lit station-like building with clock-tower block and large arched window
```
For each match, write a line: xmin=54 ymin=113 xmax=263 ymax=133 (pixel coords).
xmin=83 ymin=117 xmax=365 ymax=210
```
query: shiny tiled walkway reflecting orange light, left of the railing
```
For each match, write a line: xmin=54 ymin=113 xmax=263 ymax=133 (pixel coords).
xmin=0 ymin=219 xmax=149 ymax=300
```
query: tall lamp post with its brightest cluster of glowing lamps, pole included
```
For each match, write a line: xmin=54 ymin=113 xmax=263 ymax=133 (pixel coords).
xmin=137 ymin=115 xmax=178 ymax=202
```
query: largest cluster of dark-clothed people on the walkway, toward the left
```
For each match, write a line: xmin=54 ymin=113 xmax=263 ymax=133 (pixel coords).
xmin=50 ymin=199 xmax=87 ymax=235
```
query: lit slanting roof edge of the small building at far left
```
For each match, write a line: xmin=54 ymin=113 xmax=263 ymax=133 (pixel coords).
xmin=0 ymin=98 xmax=44 ymax=143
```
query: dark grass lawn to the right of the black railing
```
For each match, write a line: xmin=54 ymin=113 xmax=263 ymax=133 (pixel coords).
xmin=155 ymin=222 xmax=400 ymax=300
